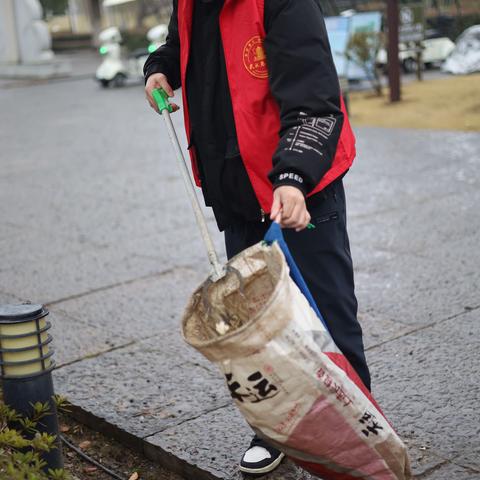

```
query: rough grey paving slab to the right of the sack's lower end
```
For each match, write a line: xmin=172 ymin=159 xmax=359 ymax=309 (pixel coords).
xmin=367 ymin=310 xmax=480 ymax=458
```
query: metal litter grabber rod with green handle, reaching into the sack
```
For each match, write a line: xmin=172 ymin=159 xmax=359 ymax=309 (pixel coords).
xmin=152 ymin=88 xmax=225 ymax=282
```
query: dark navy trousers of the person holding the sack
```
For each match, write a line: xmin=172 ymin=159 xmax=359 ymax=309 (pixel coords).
xmin=225 ymin=179 xmax=370 ymax=389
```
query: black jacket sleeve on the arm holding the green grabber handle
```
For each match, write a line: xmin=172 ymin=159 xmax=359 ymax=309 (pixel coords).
xmin=143 ymin=0 xmax=181 ymax=90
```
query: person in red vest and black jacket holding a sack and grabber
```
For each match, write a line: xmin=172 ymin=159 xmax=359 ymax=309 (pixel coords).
xmin=144 ymin=0 xmax=370 ymax=474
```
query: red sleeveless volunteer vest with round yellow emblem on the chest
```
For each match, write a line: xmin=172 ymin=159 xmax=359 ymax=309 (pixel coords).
xmin=178 ymin=0 xmax=355 ymax=212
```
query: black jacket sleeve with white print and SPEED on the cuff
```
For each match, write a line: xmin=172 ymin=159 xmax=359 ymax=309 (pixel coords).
xmin=264 ymin=0 xmax=343 ymax=194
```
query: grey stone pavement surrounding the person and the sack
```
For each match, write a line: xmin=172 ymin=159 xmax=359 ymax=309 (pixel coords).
xmin=0 ymin=79 xmax=480 ymax=480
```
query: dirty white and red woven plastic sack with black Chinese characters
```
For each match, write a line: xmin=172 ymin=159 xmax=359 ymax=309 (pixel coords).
xmin=183 ymin=227 xmax=411 ymax=480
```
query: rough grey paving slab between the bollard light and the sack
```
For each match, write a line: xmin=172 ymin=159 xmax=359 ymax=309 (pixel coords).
xmin=54 ymin=330 xmax=230 ymax=437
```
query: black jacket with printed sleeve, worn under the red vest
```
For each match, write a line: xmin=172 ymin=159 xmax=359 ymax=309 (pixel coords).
xmin=144 ymin=0 xmax=343 ymax=230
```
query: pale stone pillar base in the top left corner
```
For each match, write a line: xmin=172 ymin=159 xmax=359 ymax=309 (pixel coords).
xmin=0 ymin=0 xmax=71 ymax=78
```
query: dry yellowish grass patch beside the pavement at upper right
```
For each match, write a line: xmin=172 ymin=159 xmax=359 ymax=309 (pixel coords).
xmin=350 ymin=74 xmax=480 ymax=132
